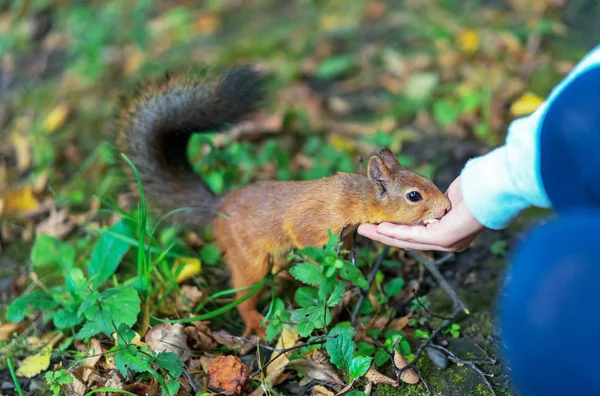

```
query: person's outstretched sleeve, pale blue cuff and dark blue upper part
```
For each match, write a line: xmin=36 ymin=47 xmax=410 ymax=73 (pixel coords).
xmin=461 ymin=46 xmax=600 ymax=229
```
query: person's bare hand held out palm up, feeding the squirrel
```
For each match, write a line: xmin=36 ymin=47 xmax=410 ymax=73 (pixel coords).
xmin=358 ymin=176 xmax=484 ymax=252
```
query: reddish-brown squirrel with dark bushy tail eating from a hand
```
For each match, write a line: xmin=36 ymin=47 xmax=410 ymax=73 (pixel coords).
xmin=116 ymin=66 xmax=451 ymax=337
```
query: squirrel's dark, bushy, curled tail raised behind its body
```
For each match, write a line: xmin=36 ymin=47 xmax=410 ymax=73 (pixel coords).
xmin=117 ymin=67 xmax=264 ymax=226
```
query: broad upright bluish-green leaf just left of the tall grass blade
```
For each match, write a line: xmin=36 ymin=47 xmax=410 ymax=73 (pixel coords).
xmin=88 ymin=220 xmax=134 ymax=287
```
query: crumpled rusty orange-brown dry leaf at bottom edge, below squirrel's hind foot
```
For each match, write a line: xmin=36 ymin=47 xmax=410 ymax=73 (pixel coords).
xmin=207 ymin=355 xmax=250 ymax=395
